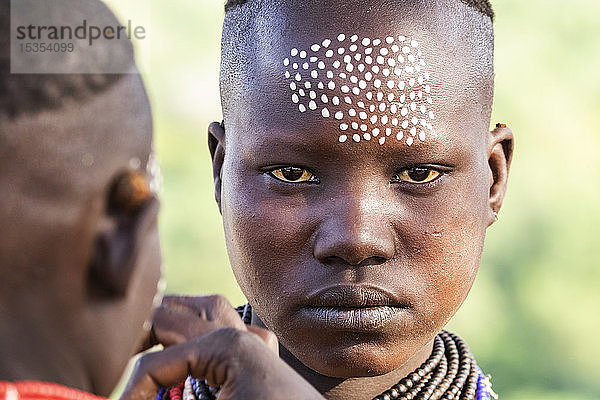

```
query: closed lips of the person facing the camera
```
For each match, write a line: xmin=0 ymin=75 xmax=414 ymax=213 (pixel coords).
xmin=300 ymin=285 xmax=408 ymax=332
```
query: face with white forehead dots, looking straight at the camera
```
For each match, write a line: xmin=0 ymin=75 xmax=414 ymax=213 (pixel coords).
xmin=213 ymin=2 xmax=500 ymax=377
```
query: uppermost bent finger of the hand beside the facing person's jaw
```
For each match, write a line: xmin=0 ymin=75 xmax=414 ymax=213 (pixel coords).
xmin=163 ymin=295 xmax=245 ymax=330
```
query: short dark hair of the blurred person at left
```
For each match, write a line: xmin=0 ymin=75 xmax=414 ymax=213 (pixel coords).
xmin=0 ymin=0 xmax=135 ymax=119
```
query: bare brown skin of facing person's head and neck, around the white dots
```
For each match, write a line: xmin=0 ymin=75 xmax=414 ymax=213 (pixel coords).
xmin=209 ymin=2 xmax=512 ymax=399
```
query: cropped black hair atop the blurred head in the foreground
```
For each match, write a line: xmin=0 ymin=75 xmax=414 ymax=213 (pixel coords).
xmin=0 ymin=0 xmax=134 ymax=118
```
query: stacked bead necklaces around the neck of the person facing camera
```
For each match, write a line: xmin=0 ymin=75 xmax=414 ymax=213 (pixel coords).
xmin=157 ymin=304 xmax=498 ymax=400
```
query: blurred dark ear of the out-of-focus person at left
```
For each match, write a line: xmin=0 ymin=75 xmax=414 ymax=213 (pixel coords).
xmin=88 ymin=197 xmax=159 ymax=297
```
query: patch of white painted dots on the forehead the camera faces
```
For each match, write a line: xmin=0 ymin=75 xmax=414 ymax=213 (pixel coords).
xmin=282 ymin=33 xmax=435 ymax=146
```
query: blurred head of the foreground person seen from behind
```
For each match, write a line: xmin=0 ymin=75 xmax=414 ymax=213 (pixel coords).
xmin=0 ymin=0 xmax=161 ymax=394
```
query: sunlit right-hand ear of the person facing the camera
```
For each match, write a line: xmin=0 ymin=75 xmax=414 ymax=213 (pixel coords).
xmin=488 ymin=124 xmax=514 ymax=226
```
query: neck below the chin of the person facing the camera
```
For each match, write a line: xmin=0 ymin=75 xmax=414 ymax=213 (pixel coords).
xmin=252 ymin=311 xmax=433 ymax=400
